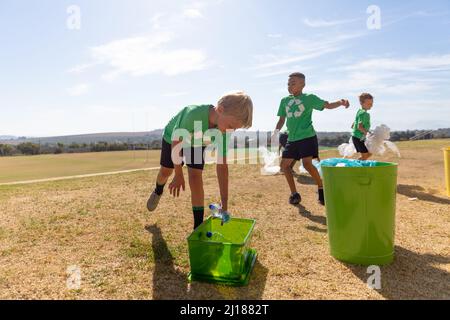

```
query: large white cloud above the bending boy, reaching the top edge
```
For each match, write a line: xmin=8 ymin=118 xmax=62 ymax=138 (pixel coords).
xmin=68 ymin=0 xmax=222 ymax=81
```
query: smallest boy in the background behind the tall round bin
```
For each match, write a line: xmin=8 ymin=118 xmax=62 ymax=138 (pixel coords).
xmin=352 ymin=93 xmax=373 ymax=160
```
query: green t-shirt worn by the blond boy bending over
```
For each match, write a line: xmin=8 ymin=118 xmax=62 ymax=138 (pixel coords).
xmin=163 ymin=105 xmax=230 ymax=156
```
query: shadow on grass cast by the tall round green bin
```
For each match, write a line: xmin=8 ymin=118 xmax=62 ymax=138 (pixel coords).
xmin=345 ymin=246 xmax=450 ymax=300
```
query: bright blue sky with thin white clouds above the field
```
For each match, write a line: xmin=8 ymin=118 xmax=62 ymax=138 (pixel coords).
xmin=0 ymin=0 xmax=450 ymax=136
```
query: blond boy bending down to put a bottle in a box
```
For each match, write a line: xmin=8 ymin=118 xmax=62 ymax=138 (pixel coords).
xmin=147 ymin=92 xmax=253 ymax=229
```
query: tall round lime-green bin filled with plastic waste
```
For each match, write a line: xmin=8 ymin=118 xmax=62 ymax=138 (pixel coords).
xmin=322 ymin=162 xmax=398 ymax=265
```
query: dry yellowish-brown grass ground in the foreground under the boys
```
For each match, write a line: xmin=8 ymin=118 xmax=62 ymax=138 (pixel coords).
xmin=0 ymin=140 xmax=450 ymax=299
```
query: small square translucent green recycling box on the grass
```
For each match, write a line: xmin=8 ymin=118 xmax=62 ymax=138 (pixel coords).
xmin=187 ymin=217 xmax=257 ymax=286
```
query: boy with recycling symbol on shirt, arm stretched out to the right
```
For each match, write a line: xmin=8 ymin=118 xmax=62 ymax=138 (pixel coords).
xmin=275 ymin=73 xmax=350 ymax=205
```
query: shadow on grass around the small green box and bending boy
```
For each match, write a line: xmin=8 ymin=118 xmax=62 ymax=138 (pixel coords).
xmin=145 ymin=225 xmax=268 ymax=300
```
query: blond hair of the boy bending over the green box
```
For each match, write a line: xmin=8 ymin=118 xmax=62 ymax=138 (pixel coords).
xmin=217 ymin=91 xmax=253 ymax=129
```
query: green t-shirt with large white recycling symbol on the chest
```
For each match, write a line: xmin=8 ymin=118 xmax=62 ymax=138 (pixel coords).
xmin=278 ymin=94 xmax=326 ymax=142
